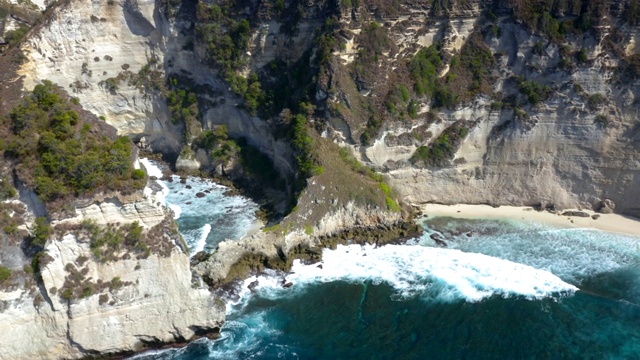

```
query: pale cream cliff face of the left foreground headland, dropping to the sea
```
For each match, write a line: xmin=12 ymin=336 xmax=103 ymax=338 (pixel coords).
xmin=0 ymin=176 xmax=225 ymax=359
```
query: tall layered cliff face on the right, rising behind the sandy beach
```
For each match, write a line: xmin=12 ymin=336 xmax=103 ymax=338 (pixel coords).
xmin=327 ymin=1 xmax=640 ymax=215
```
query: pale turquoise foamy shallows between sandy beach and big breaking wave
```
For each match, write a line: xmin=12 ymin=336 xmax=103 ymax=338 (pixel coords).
xmin=419 ymin=218 xmax=640 ymax=286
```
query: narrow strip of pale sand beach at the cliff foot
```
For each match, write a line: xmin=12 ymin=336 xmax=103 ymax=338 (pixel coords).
xmin=420 ymin=204 xmax=640 ymax=236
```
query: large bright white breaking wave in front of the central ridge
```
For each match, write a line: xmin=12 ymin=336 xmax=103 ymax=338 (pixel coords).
xmin=241 ymin=245 xmax=577 ymax=302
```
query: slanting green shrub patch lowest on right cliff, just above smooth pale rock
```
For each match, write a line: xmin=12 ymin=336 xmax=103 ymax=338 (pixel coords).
xmin=411 ymin=121 xmax=469 ymax=167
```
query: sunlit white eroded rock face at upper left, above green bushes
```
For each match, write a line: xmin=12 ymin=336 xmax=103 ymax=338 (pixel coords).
xmin=20 ymin=0 xmax=181 ymax=153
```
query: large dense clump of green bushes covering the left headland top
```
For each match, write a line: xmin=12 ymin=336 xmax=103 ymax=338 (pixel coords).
xmin=5 ymin=80 xmax=145 ymax=207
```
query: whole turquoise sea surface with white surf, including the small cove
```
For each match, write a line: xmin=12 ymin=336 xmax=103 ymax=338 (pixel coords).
xmin=136 ymin=164 xmax=640 ymax=360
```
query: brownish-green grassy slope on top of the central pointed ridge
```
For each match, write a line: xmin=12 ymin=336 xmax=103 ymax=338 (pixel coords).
xmin=271 ymin=136 xmax=400 ymax=233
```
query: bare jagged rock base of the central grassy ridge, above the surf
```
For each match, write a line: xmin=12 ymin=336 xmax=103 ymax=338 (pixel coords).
xmin=194 ymin=202 xmax=416 ymax=286
